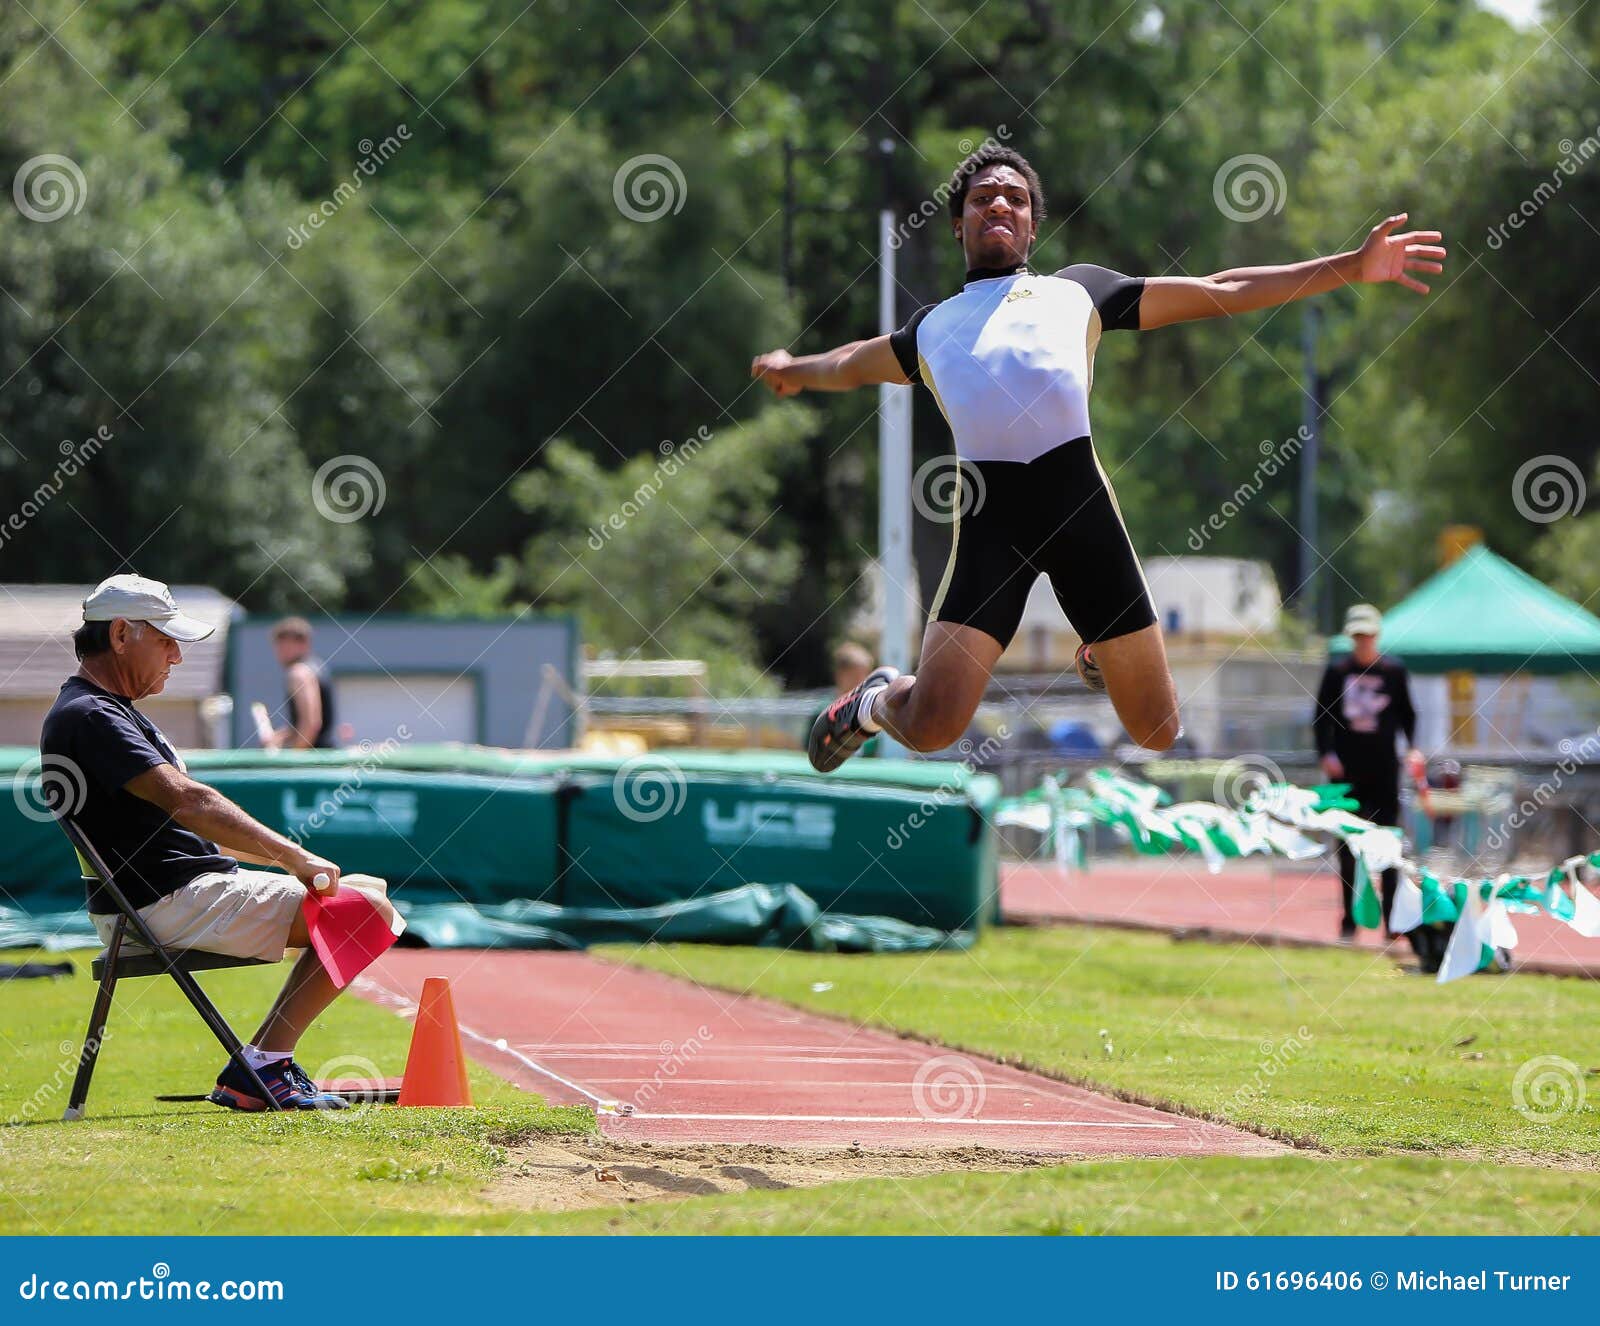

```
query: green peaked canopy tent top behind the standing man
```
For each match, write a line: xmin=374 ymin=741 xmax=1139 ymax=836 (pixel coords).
xmin=1328 ymin=544 xmax=1600 ymax=677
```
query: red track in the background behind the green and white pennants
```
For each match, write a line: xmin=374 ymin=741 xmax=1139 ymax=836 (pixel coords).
xmin=1000 ymin=856 xmax=1600 ymax=977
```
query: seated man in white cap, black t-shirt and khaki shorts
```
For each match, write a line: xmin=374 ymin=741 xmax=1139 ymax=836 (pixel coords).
xmin=38 ymin=576 xmax=394 ymax=1110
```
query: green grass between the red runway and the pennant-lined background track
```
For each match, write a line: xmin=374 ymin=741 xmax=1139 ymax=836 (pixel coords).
xmin=610 ymin=928 xmax=1600 ymax=1164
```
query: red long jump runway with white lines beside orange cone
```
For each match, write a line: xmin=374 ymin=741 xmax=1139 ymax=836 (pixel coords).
xmin=352 ymin=949 xmax=1283 ymax=1156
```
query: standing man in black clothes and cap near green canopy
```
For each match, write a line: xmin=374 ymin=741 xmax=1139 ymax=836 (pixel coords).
xmin=1312 ymin=603 xmax=1416 ymax=939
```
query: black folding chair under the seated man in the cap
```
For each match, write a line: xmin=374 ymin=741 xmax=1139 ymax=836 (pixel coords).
xmin=58 ymin=819 xmax=278 ymax=1123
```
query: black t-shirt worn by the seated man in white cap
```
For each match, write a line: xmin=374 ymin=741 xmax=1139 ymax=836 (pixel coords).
xmin=38 ymin=677 xmax=238 ymax=915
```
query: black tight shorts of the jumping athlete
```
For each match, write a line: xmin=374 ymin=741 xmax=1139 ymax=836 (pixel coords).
xmin=930 ymin=437 xmax=1155 ymax=646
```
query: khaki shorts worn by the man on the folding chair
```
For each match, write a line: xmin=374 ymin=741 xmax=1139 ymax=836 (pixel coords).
xmin=91 ymin=869 xmax=306 ymax=963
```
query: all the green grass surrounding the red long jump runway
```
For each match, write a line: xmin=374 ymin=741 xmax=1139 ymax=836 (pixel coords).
xmin=0 ymin=928 xmax=1600 ymax=1233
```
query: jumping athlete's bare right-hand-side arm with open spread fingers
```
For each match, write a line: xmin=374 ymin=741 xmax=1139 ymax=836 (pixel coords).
xmin=1139 ymin=213 xmax=1445 ymax=331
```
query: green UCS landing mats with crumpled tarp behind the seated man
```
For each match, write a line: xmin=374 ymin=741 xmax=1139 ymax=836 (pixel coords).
xmin=0 ymin=747 xmax=1000 ymax=949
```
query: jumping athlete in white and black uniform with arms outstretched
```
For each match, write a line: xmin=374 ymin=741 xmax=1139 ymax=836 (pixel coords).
xmin=750 ymin=146 xmax=1445 ymax=773
